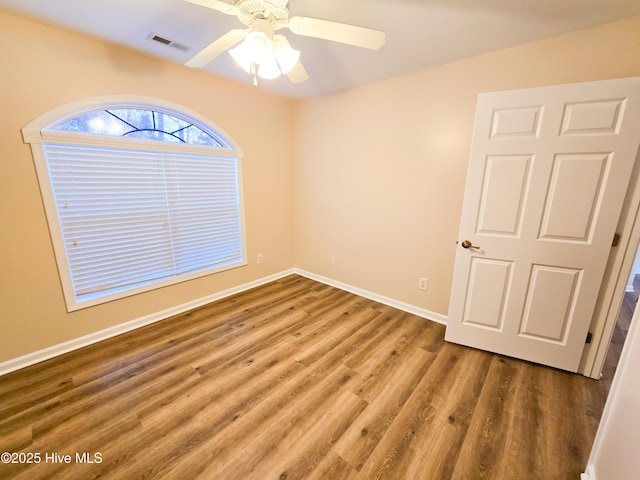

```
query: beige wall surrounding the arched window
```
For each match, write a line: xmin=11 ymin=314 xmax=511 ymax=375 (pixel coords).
xmin=0 ymin=13 xmax=293 ymax=362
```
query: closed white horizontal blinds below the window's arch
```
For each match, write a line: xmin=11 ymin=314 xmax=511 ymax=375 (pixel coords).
xmin=43 ymin=143 xmax=244 ymax=300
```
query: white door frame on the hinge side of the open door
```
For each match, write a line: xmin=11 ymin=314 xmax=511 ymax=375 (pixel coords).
xmin=578 ymin=149 xmax=640 ymax=379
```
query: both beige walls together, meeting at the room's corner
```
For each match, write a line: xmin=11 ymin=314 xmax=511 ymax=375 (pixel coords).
xmin=0 ymin=13 xmax=640 ymax=362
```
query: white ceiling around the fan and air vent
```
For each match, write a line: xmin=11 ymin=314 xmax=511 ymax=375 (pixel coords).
xmin=0 ymin=0 xmax=640 ymax=98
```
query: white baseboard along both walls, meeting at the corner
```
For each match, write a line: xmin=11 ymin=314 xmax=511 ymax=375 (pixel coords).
xmin=0 ymin=268 xmax=448 ymax=376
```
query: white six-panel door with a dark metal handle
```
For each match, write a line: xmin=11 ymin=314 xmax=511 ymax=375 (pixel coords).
xmin=446 ymin=78 xmax=640 ymax=372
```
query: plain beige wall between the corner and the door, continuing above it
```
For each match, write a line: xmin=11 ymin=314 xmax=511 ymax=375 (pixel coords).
xmin=295 ymin=17 xmax=640 ymax=315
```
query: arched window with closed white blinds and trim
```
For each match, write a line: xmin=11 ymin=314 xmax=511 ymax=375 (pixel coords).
xmin=23 ymin=97 xmax=246 ymax=311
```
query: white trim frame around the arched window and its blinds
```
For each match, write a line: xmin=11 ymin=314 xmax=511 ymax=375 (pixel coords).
xmin=22 ymin=95 xmax=247 ymax=312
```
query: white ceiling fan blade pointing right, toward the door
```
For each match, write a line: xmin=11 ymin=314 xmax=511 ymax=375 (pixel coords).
xmin=288 ymin=17 xmax=386 ymax=50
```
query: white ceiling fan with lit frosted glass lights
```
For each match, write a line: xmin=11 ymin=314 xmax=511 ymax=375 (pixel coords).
xmin=185 ymin=0 xmax=385 ymax=85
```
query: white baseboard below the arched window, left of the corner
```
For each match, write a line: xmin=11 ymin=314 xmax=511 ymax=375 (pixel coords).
xmin=0 ymin=269 xmax=295 ymax=376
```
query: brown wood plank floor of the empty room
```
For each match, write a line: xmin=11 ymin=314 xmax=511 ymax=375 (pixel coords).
xmin=0 ymin=276 xmax=606 ymax=480
